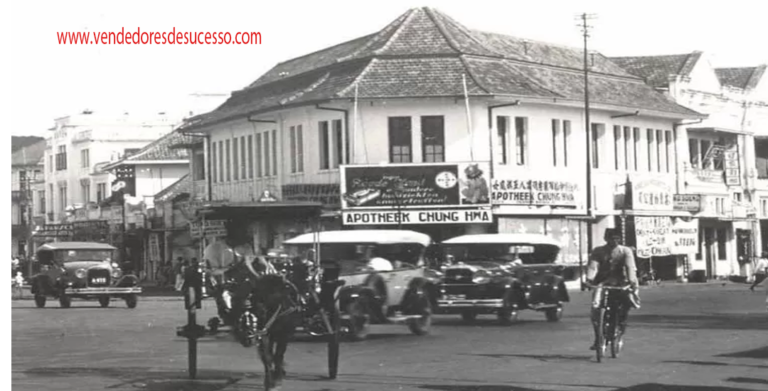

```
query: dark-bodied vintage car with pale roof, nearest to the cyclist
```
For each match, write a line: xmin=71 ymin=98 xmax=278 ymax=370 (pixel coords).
xmin=437 ymin=234 xmax=570 ymax=324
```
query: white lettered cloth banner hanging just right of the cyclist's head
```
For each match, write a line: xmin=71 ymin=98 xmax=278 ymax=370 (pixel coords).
xmin=635 ymin=216 xmax=699 ymax=258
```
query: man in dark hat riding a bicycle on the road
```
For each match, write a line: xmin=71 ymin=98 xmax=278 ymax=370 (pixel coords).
xmin=587 ymin=228 xmax=640 ymax=350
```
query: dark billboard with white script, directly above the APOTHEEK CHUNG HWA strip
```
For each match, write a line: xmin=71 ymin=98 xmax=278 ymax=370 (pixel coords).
xmin=341 ymin=163 xmax=490 ymax=213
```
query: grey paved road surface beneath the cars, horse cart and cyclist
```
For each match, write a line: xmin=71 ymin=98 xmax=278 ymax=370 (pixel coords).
xmin=11 ymin=285 xmax=768 ymax=391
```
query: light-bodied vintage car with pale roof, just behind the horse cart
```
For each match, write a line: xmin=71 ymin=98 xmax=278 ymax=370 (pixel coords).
xmin=283 ymin=230 xmax=436 ymax=340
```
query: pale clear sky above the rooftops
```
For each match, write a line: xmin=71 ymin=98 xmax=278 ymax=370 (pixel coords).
xmin=11 ymin=0 xmax=768 ymax=136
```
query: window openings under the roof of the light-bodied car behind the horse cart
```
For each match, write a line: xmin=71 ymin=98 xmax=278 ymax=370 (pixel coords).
xmin=286 ymin=243 xmax=424 ymax=273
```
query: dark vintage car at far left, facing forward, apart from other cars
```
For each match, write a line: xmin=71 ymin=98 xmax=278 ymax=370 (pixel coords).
xmin=30 ymin=242 xmax=141 ymax=308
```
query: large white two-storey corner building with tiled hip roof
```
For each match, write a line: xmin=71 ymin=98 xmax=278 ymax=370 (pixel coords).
xmin=184 ymin=9 xmax=704 ymax=278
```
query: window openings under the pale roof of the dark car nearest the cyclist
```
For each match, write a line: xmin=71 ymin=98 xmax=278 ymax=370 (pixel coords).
xmin=443 ymin=243 xmax=560 ymax=265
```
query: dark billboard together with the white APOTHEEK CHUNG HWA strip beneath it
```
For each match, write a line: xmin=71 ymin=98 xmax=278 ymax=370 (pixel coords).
xmin=341 ymin=163 xmax=495 ymax=242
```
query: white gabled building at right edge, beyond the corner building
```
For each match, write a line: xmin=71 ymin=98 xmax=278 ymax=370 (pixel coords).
xmin=611 ymin=52 xmax=768 ymax=278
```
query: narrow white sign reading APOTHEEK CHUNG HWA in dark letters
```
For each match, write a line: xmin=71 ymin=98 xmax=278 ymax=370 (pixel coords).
xmin=342 ymin=209 xmax=493 ymax=225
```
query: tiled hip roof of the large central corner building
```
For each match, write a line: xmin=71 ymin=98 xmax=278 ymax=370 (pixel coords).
xmin=184 ymin=8 xmax=701 ymax=131
